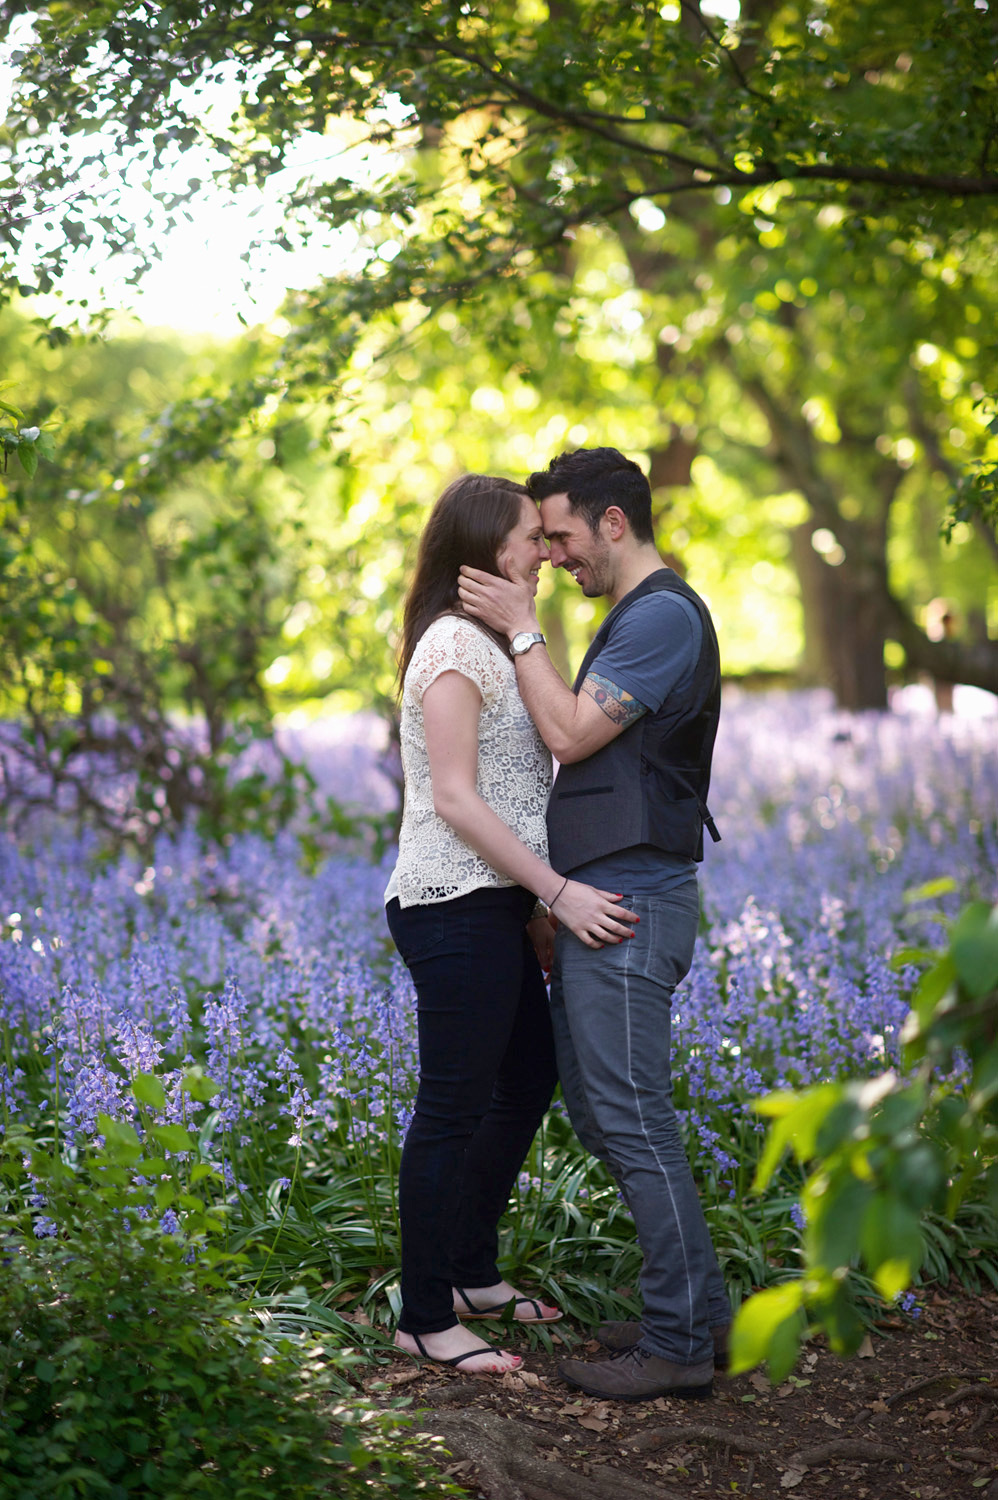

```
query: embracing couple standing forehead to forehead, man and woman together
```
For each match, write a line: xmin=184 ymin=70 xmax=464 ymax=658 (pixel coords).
xmin=386 ymin=449 xmax=731 ymax=1401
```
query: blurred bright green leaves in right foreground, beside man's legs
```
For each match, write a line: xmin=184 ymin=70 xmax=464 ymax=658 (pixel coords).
xmin=732 ymin=882 xmax=998 ymax=1380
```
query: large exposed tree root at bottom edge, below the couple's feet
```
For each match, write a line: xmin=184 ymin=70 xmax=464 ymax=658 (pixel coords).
xmin=422 ymin=1410 xmax=681 ymax=1500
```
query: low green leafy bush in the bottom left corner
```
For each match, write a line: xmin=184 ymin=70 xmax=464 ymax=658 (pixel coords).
xmin=0 ymin=1098 xmax=456 ymax=1500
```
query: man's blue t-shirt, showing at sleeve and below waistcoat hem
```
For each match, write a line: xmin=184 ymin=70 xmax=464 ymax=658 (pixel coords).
xmin=566 ymin=593 xmax=704 ymax=896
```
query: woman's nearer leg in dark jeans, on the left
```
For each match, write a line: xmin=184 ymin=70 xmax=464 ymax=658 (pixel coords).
xmin=389 ymin=887 xmax=546 ymax=1334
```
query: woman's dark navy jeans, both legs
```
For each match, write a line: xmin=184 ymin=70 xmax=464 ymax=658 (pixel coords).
xmin=386 ymin=885 xmax=557 ymax=1334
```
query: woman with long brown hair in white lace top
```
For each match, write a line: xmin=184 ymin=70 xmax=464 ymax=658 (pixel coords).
xmin=386 ymin=474 xmax=632 ymax=1374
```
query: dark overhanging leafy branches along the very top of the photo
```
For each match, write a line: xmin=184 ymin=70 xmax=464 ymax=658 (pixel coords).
xmin=6 ymin=0 xmax=998 ymax=302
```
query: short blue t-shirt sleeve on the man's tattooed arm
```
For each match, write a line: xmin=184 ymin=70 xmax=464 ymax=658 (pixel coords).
xmin=588 ymin=593 xmax=704 ymax=713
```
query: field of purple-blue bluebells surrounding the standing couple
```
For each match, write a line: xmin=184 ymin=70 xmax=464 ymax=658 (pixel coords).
xmin=0 ymin=693 xmax=998 ymax=1305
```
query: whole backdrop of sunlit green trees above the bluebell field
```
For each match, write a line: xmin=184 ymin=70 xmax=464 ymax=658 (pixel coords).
xmin=0 ymin=0 xmax=998 ymax=809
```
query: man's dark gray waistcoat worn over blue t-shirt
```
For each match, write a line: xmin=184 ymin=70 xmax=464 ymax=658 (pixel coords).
xmin=548 ymin=569 xmax=720 ymax=872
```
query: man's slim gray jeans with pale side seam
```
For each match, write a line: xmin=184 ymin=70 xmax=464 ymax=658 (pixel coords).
xmin=551 ymin=879 xmax=731 ymax=1365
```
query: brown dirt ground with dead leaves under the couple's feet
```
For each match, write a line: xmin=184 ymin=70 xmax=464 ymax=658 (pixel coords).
xmin=372 ymin=1290 xmax=998 ymax=1500
